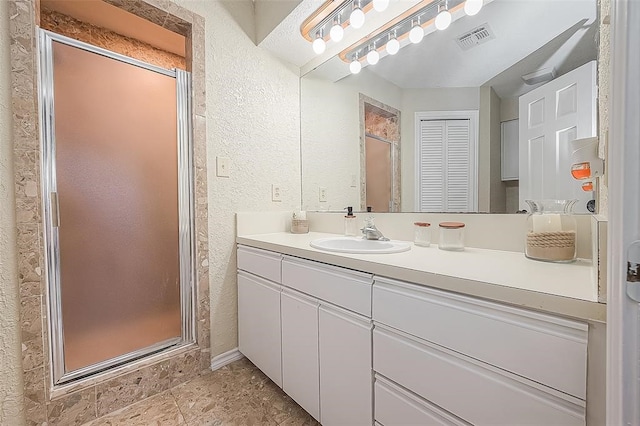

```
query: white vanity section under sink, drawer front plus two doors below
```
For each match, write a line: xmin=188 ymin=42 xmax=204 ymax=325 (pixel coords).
xmin=282 ymin=256 xmax=373 ymax=426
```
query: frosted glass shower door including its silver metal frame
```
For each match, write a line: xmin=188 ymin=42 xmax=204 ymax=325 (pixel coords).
xmin=39 ymin=30 xmax=194 ymax=384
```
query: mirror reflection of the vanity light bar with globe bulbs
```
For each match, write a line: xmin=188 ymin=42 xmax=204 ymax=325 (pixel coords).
xmin=339 ymin=0 xmax=488 ymax=72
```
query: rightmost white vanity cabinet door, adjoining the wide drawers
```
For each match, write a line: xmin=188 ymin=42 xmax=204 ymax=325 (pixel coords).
xmin=319 ymin=305 xmax=373 ymax=426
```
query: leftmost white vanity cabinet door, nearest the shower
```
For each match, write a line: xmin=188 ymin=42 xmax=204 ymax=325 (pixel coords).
xmin=238 ymin=272 xmax=282 ymax=387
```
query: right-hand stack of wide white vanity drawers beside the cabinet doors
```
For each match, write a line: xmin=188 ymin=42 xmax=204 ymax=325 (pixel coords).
xmin=373 ymin=277 xmax=587 ymax=425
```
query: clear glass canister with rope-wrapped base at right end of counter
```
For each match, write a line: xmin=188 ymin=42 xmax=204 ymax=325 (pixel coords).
xmin=525 ymin=200 xmax=578 ymax=263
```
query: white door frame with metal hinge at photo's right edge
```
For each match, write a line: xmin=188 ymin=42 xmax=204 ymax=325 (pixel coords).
xmin=607 ymin=0 xmax=640 ymax=425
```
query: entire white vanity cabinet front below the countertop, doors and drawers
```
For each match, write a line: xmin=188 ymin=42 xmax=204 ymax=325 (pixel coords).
xmin=238 ymin=246 xmax=597 ymax=426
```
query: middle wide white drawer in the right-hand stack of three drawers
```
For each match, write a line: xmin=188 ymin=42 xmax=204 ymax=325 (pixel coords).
xmin=373 ymin=326 xmax=585 ymax=425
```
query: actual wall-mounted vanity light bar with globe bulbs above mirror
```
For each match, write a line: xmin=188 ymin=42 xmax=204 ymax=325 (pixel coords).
xmin=300 ymin=0 xmax=389 ymax=53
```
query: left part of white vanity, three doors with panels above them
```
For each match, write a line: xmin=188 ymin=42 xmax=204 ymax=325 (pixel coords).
xmin=238 ymin=246 xmax=373 ymax=426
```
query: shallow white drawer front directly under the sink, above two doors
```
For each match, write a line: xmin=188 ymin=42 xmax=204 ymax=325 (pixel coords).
xmin=282 ymin=256 xmax=373 ymax=318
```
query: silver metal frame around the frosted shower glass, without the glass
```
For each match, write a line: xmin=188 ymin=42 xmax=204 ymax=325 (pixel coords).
xmin=38 ymin=29 xmax=196 ymax=386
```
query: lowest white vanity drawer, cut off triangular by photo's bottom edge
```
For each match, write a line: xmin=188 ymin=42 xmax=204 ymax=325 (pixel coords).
xmin=374 ymin=375 xmax=470 ymax=426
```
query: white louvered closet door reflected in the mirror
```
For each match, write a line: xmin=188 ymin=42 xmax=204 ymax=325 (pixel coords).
xmin=419 ymin=120 xmax=474 ymax=212
